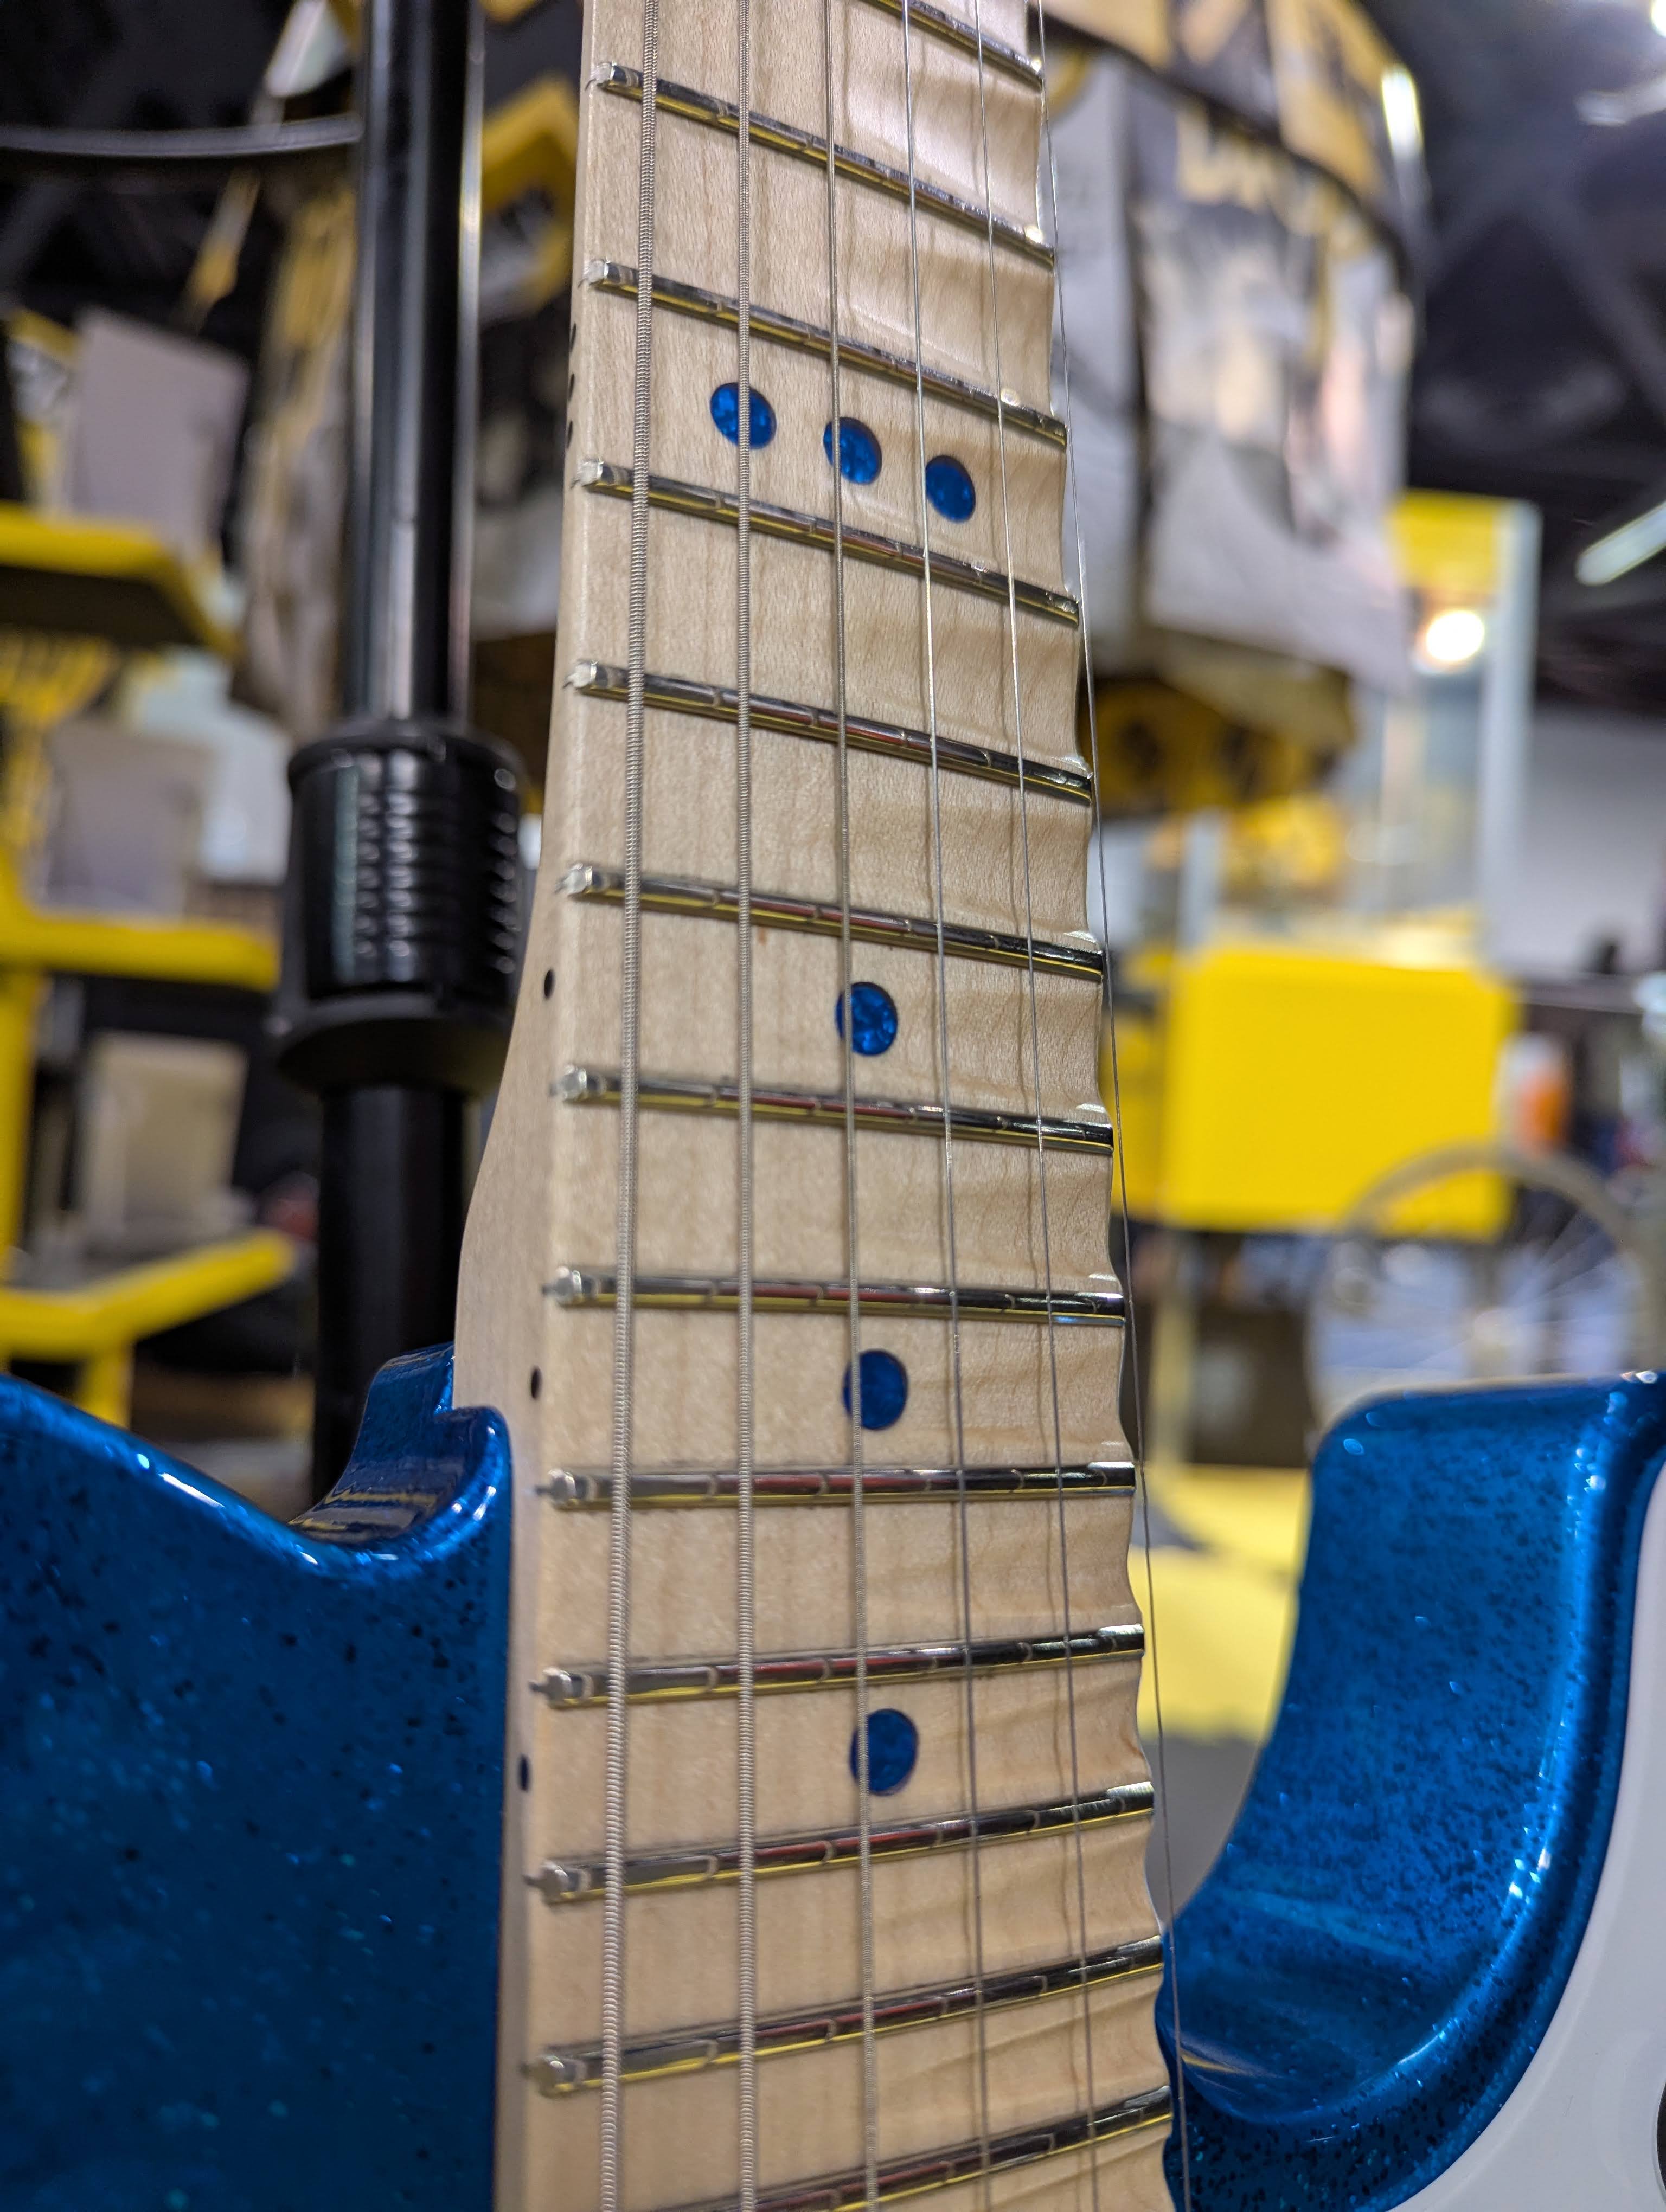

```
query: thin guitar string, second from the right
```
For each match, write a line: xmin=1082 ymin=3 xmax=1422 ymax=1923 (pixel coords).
xmin=956 ymin=0 xmax=1100 ymax=2212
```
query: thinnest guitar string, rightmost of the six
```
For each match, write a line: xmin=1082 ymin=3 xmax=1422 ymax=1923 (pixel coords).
xmin=1035 ymin=17 xmax=1193 ymax=2212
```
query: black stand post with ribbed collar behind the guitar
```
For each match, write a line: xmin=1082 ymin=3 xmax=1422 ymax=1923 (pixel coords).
xmin=274 ymin=0 xmax=520 ymax=1495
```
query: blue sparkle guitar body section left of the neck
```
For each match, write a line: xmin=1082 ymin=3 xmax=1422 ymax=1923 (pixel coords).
xmin=0 ymin=1352 xmax=509 ymax=2212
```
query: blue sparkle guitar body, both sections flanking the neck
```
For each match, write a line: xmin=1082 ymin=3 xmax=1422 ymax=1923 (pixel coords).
xmin=0 ymin=1354 xmax=1666 ymax=2212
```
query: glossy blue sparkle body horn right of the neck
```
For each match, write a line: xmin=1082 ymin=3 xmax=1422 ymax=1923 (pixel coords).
xmin=1157 ymin=1376 xmax=1666 ymax=2212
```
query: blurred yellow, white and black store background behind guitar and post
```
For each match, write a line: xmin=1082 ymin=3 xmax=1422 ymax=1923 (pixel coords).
xmin=0 ymin=0 xmax=1666 ymax=1893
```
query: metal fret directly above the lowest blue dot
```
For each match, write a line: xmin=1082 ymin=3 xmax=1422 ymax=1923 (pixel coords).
xmin=533 ymin=1622 xmax=1146 ymax=1712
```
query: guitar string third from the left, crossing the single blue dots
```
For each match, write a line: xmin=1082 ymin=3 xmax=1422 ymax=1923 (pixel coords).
xmin=821 ymin=0 xmax=879 ymax=2205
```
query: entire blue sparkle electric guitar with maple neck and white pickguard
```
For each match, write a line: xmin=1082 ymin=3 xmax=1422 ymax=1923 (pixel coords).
xmin=0 ymin=0 xmax=1666 ymax=2212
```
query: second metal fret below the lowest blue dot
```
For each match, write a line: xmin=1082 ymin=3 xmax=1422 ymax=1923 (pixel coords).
xmin=527 ymin=1935 xmax=1164 ymax=2097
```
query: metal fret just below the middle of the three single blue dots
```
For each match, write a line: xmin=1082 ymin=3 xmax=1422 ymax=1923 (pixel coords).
xmin=537 ymin=1460 xmax=1133 ymax=1511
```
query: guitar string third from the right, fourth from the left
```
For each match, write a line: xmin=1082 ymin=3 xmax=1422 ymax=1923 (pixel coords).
xmin=900 ymin=0 xmax=989 ymax=2203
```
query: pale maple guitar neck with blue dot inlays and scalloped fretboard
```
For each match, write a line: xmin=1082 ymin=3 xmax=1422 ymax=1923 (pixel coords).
xmin=456 ymin=0 xmax=1168 ymax=2212
